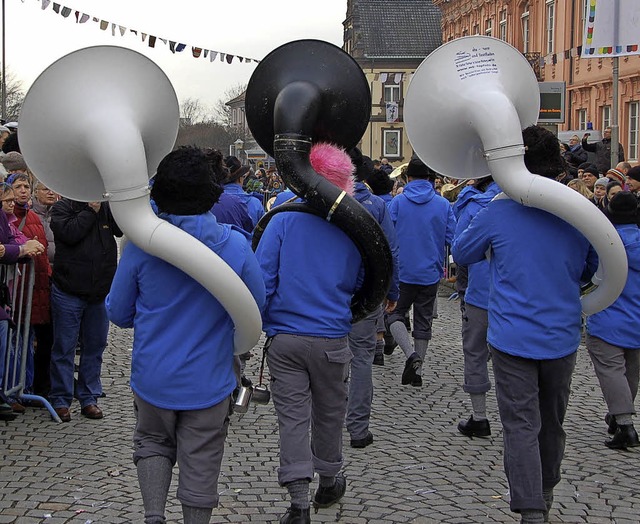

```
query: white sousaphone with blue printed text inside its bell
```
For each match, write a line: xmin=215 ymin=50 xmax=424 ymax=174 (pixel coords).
xmin=404 ymin=36 xmax=628 ymax=315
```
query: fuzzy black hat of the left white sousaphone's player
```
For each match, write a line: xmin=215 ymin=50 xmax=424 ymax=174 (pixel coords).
xmin=151 ymin=146 xmax=222 ymax=215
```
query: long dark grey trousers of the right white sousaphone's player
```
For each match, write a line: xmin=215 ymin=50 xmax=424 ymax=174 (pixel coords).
xmin=490 ymin=346 xmax=576 ymax=512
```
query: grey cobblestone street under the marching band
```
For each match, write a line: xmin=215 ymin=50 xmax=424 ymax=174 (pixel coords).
xmin=0 ymin=289 xmax=640 ymax=524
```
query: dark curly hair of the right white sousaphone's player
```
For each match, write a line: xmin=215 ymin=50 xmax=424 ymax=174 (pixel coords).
xmin=522 ymin=126 xmax=567 ymax=178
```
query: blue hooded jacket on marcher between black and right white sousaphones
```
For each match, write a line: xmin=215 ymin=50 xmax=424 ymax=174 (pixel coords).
xmin=389 ymin=180 xmax=456 ymax=286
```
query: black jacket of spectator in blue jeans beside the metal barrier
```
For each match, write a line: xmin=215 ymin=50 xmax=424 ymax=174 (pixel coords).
xmin=51 ymin=198 xmax=122 ymax=302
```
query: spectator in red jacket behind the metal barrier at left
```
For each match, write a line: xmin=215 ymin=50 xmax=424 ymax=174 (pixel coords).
xmin=5 ymin=172 xmax=52 ymax=410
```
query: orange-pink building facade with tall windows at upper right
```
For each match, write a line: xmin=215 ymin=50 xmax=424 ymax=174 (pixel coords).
xmin=433 ymin=0 xmax=640 ymax=163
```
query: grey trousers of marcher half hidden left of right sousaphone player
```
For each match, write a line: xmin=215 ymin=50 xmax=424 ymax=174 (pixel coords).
xmin=460 ymin=303 xmax=491 ymax=394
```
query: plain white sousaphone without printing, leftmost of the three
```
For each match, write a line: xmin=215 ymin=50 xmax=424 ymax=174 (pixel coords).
xmin=20 ymin=46 xmax=262 ymax=354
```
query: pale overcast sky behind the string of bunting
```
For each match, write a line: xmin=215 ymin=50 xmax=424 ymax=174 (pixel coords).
xmin=4 ymin=0 xmax=347 ymax=115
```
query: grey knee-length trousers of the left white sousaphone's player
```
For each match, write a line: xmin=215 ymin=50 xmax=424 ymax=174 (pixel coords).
xmin=133 ymin=395 xmax=231 ymax=508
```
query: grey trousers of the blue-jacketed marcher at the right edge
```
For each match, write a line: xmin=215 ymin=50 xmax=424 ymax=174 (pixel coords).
xmin=586 ymin=335 xmax=640 ymax=415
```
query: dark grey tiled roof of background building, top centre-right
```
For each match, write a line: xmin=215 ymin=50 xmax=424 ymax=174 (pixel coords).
xmin=353 ymin=0 xmax=442 ymax=59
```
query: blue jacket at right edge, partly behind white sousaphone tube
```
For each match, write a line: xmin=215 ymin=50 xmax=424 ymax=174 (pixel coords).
xmin=587 ymin=224 xmax=640 ymax=349
